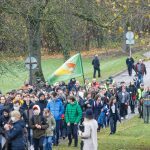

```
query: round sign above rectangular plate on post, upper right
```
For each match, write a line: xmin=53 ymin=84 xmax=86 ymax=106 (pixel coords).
xmin=126 ymin=31 xmax=135 ymax=57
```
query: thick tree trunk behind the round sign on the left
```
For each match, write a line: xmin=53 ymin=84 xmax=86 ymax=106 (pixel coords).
xmin=26 ymin=10 xmax=45 ymax=83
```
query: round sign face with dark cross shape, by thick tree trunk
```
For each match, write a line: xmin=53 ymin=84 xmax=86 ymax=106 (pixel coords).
xmin=25 ymin=57 xmax=37 ymax=70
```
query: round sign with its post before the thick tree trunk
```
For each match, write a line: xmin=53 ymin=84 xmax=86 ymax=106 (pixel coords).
xmin=25 ymin=57 xmax=37 ymax=85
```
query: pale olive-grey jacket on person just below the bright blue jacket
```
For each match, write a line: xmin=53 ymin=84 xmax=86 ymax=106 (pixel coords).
xmin=46 ymin=115 xmax=56 ymax=136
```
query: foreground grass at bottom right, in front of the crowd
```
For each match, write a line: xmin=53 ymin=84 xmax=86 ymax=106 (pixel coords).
xmin=54 ymin=116 xmax=150 ymax=150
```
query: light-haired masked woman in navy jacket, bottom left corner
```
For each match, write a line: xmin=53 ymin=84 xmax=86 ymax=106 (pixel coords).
xmin=4 ymin=110 xmax=25 ymax=150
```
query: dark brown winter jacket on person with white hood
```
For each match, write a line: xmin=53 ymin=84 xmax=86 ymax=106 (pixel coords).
xmin=30 ymin=115 xmax=49 ymax=139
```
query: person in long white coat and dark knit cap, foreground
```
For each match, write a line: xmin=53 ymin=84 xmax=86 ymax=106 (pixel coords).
xmin=79 ymin=109 xmax=98 ymax=150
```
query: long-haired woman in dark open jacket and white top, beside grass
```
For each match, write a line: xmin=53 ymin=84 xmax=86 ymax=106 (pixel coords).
xmin=109 ymin=96 xmax=120 ymax=134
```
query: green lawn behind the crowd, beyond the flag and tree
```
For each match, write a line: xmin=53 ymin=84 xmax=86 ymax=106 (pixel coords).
xmin=0 ymin=51 xmax=143 ymax=92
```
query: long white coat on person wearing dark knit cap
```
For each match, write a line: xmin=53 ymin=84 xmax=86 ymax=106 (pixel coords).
xmin=81 ymin=119 xmax=98 ymax=150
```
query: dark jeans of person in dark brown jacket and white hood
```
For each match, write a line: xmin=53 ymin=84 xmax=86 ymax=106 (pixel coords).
xmin=33 ymin=136 xmax=45 ymax=150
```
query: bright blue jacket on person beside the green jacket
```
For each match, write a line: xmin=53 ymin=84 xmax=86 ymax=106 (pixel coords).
xmin=47 ymin=99 xmax=64 ymax=120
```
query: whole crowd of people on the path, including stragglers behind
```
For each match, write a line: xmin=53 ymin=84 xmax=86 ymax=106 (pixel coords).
xmin=0 ymin=56 xmax=150 ymax=150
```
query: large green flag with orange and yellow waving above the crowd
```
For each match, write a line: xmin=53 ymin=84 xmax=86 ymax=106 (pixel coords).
xmin=48 ymin=53 xmax=83 ymax=84
